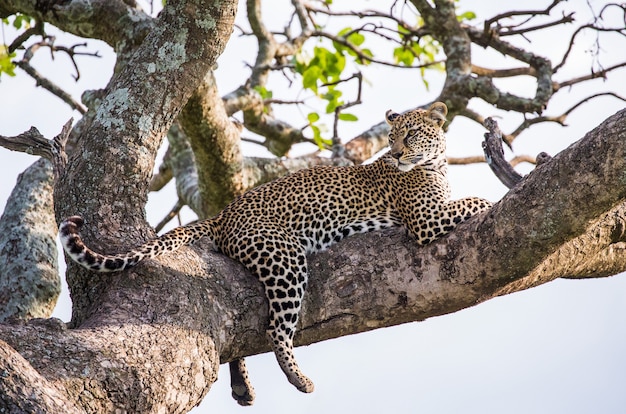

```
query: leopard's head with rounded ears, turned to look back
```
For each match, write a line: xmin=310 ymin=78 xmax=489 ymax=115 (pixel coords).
xmin=385 ymin=102 xmax=448 ymax=171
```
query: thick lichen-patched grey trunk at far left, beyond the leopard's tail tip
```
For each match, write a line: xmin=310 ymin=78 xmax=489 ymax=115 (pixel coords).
xmin=0 ymin=159 xmax=61 ymax=321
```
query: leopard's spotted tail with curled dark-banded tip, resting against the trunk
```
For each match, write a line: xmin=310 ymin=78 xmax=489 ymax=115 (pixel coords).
xmin=59 ymin=216 xmax=216 ymax=272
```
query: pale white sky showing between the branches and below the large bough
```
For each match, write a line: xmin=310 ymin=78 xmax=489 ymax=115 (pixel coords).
xmin=0 ymin=0 xmax=626 ymax=414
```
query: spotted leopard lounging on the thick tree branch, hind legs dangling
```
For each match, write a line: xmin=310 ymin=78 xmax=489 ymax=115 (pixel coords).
xmin=59 ymin=102 xmax=491 ymax=405
